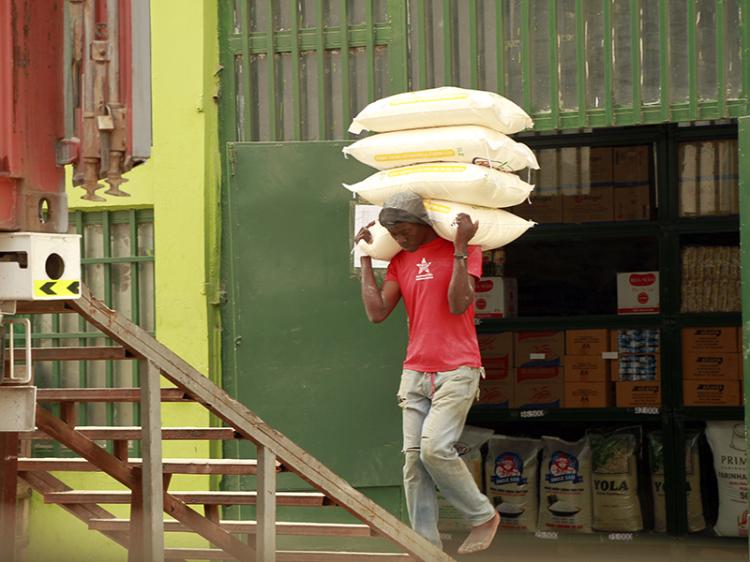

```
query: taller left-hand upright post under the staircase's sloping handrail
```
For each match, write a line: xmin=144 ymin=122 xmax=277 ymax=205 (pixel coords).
xmin=140 ymin=360 xmax=164 ymax=562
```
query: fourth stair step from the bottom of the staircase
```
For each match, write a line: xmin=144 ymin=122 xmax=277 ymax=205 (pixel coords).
xmin=18 ymin=457 xmax=282 ymax=474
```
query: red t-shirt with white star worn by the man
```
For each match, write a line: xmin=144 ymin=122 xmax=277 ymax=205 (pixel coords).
xmin=385 ymin=238 xmax=482 ymax=373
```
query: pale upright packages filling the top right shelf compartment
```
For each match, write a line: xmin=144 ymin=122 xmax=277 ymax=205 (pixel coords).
xmin=677 ymin=139 xmax=740 ymax=217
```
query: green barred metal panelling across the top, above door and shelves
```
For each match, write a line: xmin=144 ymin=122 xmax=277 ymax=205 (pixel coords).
xmin=221 ymin=0 xmax=750 ymax=141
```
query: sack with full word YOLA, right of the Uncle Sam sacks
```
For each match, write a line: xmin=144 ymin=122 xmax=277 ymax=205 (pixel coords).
xmin=588 ymin=428 xmax=643 ymax=533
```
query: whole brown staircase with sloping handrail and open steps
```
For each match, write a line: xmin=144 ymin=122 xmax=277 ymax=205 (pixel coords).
xmin=0 ymin=287 xmax=452 ymax=562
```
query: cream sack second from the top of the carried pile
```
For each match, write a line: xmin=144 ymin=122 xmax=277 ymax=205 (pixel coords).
xmin=342 ymin=125 xmax=539 ymax=172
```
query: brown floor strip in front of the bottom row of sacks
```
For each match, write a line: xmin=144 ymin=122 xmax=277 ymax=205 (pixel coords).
xmin=445 ymin=533 xmax=750 ymax=562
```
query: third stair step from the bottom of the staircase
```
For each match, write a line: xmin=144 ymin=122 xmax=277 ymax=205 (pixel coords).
xmin=44 ymin=490 xmax=333 ymax=507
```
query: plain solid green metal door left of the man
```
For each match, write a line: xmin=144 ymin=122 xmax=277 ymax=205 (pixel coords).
xmin=222 ymin=142 xmax=407 ymax=487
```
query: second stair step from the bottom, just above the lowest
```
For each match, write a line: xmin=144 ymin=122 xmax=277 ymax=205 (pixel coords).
xmin=89 ymin=518 xmax=376 ymax=537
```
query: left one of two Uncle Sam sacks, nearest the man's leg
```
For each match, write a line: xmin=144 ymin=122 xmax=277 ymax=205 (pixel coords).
xmin=485 ymin=435 xmax=541 ymax=532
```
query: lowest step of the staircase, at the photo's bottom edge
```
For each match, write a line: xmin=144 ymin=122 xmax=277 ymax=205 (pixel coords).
xmin=164 ymin=548 xmax=414 ymax=562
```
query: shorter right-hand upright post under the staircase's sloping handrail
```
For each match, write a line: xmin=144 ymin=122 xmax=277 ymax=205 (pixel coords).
xmin=256 ymin=445 xmax=276 ymax=562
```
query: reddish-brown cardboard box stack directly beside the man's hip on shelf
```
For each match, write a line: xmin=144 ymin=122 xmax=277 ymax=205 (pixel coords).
xmin=478 ymin=332 xmax=513 ymax=408
